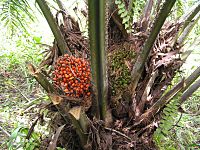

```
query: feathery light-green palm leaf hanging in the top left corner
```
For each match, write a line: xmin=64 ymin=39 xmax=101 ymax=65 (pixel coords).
xmin=0 ymin=0 xmax=35 ymax=34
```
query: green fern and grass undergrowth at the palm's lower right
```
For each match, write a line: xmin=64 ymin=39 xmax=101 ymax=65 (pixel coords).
xmin=153 ymin=74 xmax=200 ymax=150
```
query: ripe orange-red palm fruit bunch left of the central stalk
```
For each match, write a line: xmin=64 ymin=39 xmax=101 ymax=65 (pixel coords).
xmin=52 ymin=54 xmax=91 ymax=98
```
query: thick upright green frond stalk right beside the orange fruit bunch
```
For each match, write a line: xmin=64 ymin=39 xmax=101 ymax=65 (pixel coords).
xmin=88 ymin=0 xmax=107 ymax=120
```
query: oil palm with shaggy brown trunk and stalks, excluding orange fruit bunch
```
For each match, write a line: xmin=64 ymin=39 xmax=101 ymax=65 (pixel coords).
xmin=3 ymin=0 xmax=200 ymax=149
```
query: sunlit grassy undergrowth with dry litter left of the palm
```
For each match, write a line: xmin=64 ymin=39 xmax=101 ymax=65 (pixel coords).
xmin=0 ymin=34 xmax=50 ymax=150
